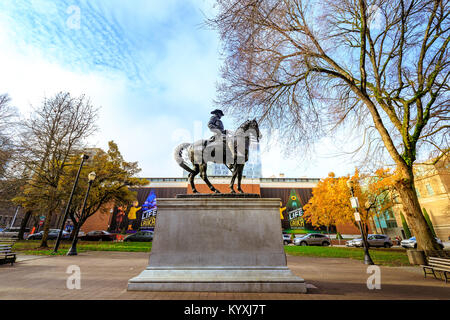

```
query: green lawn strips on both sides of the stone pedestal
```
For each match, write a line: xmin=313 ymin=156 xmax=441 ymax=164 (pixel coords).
xmin=14 ymin=240 xmax=410 ymax=266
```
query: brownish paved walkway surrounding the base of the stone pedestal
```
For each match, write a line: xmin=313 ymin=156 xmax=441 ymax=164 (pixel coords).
xmin=0 ymin=251 xmax=450 ymax=300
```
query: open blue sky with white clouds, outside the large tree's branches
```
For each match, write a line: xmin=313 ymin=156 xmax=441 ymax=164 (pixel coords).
xmin=0 ymin=0 xmax=358 ymax=177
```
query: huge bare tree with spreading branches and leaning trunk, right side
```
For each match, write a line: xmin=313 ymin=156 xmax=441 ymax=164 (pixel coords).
xmin=207 ymin=0 xmax=450 ymax=250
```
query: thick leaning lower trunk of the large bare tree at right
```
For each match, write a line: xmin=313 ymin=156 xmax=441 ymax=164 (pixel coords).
xmin=395 ymin=168 xmax=440 ymax=251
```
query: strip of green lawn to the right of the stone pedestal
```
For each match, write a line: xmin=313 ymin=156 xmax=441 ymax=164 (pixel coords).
xmin=284 ymin=246 xmax=410 ymax=266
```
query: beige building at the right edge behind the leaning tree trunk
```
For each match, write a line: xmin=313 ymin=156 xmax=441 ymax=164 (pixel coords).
xmin=393 ymin=157 xmax=450 ymax=241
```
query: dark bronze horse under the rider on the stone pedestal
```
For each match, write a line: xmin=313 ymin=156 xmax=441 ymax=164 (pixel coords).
xmin=174 ymin=119 xmax=261 ymax=193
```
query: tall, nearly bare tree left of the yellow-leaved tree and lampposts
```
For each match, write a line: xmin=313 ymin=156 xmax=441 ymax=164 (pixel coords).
xmin=16 ymin=92 xmax=97 ymax=247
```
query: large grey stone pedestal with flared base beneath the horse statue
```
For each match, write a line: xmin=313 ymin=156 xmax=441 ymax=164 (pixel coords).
xmin=128 ymin=197 xmax=306 ymax=293
